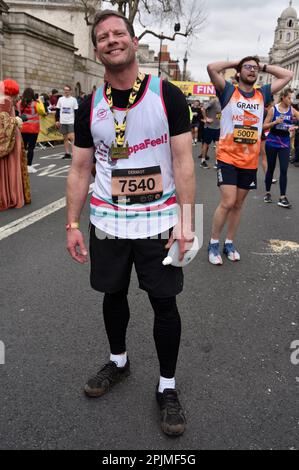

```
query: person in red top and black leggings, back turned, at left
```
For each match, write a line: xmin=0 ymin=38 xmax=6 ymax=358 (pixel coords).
xmin=18 ymin=88 xmax=46 ymax=173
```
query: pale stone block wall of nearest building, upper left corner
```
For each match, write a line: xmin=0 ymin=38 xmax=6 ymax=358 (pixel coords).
xmin=2 ymin=13 xmax=76 ymax=92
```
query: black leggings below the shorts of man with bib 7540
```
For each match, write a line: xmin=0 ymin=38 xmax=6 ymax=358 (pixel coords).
xmin=103 ymin=290 xmax=181 ymax=379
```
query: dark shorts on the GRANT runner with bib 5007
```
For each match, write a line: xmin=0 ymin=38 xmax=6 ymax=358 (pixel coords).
xmin=217 ymin=160 xmax=257 ymax=189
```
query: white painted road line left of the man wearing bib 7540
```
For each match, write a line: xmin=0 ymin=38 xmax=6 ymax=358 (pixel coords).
xmin=0 ymin=184 xmax=93 ymax=241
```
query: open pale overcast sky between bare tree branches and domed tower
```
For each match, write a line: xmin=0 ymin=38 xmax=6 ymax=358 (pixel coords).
xmin=138 ymin=0 xmax=299 ymax=81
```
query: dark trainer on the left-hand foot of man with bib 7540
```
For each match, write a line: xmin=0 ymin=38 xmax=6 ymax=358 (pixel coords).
xmin=84 ymin=359 xmax=130 ymax=397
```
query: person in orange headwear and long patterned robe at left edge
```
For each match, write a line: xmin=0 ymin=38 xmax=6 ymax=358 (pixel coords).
xmin=0 ymin=79 xmax=31 ymax=211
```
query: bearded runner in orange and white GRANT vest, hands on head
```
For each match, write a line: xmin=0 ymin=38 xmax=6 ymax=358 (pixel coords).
xmin=208 ymin=56 xmax=293 ymax=265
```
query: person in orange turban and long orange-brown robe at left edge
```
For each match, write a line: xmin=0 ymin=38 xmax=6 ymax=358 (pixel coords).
xmin=0 ymin=79 xmax=31 ymax=211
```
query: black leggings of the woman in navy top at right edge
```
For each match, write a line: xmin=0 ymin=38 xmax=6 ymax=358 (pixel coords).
xmin=265 ymin=145 xmax=290 ymax=196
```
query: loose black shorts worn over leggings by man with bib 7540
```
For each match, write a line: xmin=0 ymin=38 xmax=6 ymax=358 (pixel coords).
xmin=89 ymin=225 xmax=184 ymax=298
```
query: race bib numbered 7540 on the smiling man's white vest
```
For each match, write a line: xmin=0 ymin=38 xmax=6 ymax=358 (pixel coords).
xmin=112 ymin=166 xmax=163 ymax=204
